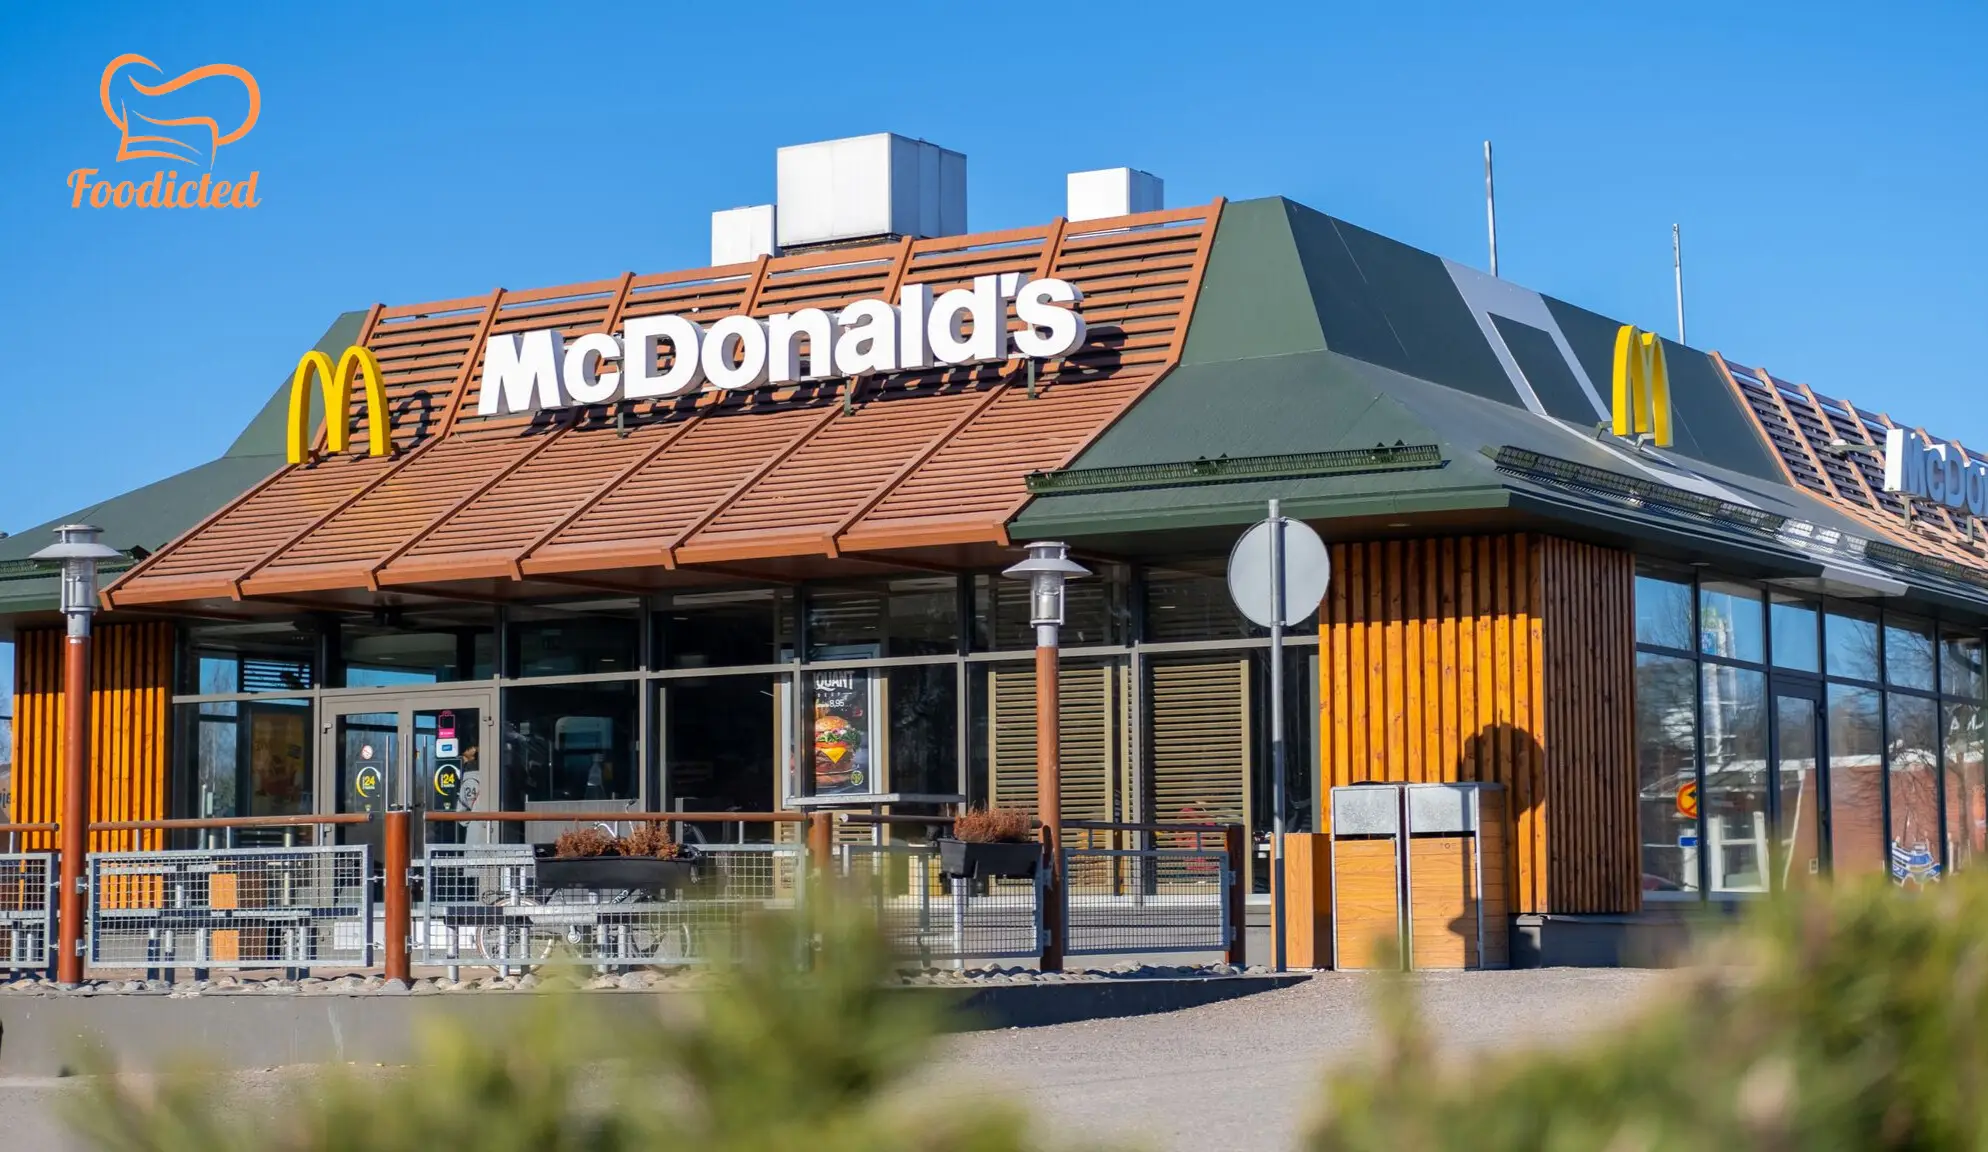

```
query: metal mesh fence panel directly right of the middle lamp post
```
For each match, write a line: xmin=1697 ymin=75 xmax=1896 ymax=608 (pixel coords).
xmin=1064 ymin=848 xmax=1235 ymax=955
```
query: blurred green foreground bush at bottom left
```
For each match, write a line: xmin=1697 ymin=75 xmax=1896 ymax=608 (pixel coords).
xmin=74 ymin=901 xmax=1089 ymax=1152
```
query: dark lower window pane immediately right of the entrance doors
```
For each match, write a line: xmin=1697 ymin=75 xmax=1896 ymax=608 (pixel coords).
xmin=503 ymin=680 xmax=640 ymax=812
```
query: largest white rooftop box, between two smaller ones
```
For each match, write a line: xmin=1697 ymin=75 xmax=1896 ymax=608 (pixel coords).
xmin=777 ymin=131 xmax=966 ymax=249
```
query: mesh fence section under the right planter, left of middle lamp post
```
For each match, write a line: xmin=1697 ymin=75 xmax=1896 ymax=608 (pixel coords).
xmin=839 ymin=844 xmax=1042 ymax=961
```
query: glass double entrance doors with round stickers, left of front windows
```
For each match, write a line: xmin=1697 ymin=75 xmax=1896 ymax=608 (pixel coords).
xmin=320 ymin=692 xmax=497 ymax=860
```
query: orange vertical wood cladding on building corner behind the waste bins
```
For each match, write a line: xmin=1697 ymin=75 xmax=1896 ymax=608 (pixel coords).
xmin=1320 ymin=533 xmax=1642 ymax=913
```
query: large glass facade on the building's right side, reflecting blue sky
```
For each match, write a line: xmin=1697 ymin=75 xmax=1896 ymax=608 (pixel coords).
xmin=1636 ymin=565 xmax=1988 ymax=899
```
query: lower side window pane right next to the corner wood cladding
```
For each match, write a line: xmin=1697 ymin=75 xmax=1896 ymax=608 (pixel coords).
xmin=1636 ymin=653 xmax=1698 ymax=899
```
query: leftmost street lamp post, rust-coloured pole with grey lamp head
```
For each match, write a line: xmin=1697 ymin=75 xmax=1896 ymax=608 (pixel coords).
xmin=32 ymin=523 xmax=119 ymax=985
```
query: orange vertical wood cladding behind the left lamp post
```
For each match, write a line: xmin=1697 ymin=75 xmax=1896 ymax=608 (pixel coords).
xmin=10 ymin=623 xmax=173 ymax=850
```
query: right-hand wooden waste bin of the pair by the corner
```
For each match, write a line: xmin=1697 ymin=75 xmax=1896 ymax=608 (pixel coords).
xmin=1402 ymin=784 xmax=1511 ymax=969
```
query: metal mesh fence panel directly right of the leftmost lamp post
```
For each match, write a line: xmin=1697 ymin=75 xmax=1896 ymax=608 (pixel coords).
xmin=87 ymin=846 xmax=374 ymax=969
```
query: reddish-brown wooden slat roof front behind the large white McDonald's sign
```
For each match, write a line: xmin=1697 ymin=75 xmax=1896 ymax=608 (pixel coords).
xmin=105 ymin=201 xmax=1223 ymax=607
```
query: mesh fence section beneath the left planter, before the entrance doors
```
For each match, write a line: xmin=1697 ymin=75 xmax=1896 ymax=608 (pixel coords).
xmin=414 ymin=844 xmax=807 ymax=967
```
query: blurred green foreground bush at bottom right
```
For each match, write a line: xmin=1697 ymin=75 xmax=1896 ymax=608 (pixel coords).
xmin=1308 ymin=875 xmax=1988 ymax=1152
